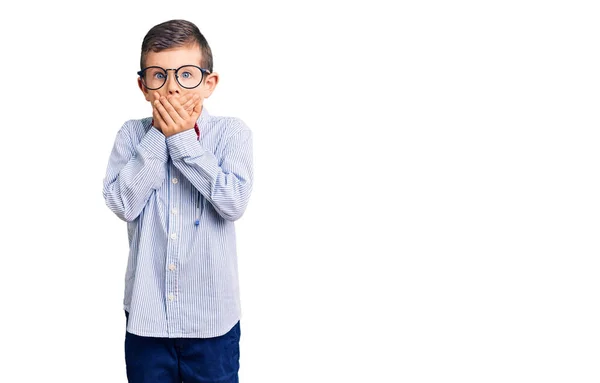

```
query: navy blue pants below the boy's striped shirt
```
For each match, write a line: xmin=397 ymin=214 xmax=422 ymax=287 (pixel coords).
xmin=125 ymin=311 xmax=241 ymax=383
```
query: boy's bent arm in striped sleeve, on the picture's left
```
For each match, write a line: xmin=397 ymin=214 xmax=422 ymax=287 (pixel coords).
xmin=103 ymin=122 xmax=168 ymax=222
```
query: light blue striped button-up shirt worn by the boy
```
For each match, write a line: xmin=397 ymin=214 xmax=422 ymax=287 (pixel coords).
xmin=103 ymin=107 xmax=253 ymax=338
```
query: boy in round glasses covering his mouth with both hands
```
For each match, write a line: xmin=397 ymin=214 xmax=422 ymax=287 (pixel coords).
xmin=103 ymin=20 xmax=253 ymax=383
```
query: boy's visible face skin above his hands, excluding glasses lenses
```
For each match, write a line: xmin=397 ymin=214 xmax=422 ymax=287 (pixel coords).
xmin=138 ymin=45 xmax=219 ymax=103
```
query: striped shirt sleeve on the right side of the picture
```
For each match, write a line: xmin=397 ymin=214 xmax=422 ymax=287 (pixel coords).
xmin=166 ymin=120 xmax=253 ymax=221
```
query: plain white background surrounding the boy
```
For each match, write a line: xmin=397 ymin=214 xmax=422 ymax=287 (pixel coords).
xmin=0 ymin=0 xmax=600 ymax=383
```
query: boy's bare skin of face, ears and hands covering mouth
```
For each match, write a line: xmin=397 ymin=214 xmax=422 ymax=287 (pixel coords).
xmin=138 ymin=44 xmax=219 ymax=137
